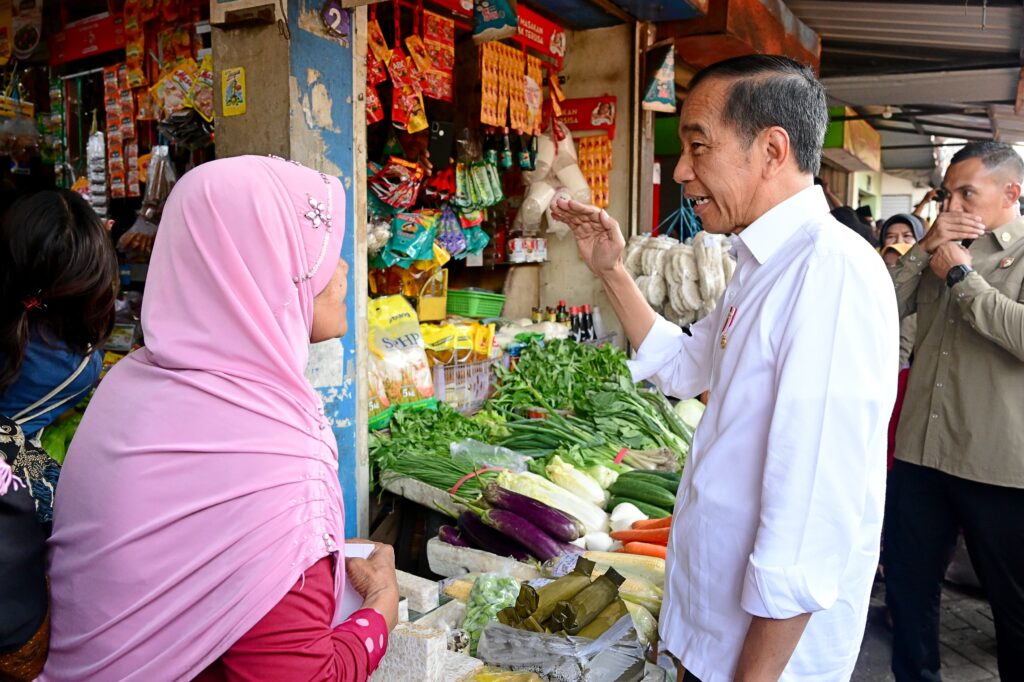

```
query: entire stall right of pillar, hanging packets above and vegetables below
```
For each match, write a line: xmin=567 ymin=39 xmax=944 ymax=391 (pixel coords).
xmin=352 ymin=0 xmax=720 ymax=679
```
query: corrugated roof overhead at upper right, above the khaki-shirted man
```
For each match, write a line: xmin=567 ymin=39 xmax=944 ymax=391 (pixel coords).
xmin=786 ymin=0 xmax=1024 ymax=169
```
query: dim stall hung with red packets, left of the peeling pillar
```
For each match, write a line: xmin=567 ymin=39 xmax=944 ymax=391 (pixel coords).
xmin=0 ymin=0 xmax=214 ymax=462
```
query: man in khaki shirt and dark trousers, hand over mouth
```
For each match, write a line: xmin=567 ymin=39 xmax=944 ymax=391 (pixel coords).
xmin=884 ymin=142 xmax=1024 ymax=682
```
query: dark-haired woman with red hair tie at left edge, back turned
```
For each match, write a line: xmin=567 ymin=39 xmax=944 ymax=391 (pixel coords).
xmin=0 ymin=189 xmax=117 ymax=680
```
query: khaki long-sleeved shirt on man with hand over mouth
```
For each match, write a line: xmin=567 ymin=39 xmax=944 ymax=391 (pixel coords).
xmin=892 ymin=218 xmax=1024 ymax=487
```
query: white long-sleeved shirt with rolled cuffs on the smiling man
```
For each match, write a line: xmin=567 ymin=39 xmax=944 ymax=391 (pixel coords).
xmin=631 ymin=187 xmax=899 ymax=682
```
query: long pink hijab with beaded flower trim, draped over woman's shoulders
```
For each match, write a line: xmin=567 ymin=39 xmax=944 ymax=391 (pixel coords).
xmin=42 ymin=157 xmax=345 ymax=682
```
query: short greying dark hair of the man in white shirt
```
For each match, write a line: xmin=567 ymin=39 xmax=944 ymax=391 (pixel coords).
xmin=689 ymin=54 xmax=828 ymax=174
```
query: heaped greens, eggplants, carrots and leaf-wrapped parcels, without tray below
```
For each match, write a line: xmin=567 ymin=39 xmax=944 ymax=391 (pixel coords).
xmin=380 ymin=339 xmax=701 ymax=630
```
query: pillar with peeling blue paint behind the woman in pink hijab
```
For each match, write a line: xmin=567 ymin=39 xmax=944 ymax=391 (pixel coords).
xmin=213 ymin=0 xmax=369 ymax=537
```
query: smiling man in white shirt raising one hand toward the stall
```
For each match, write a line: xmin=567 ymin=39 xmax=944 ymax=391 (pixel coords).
xmin=555 ymin=55 xmax=899 ymax=682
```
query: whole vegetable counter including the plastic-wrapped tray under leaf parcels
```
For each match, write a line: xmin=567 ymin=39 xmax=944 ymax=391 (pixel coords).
xmin=371 ymin=331 xmax=702 ymax=680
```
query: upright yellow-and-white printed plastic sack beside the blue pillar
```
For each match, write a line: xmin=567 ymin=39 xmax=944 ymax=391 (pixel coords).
xmin=369 ymin=296 xmax=434 ymax=406
